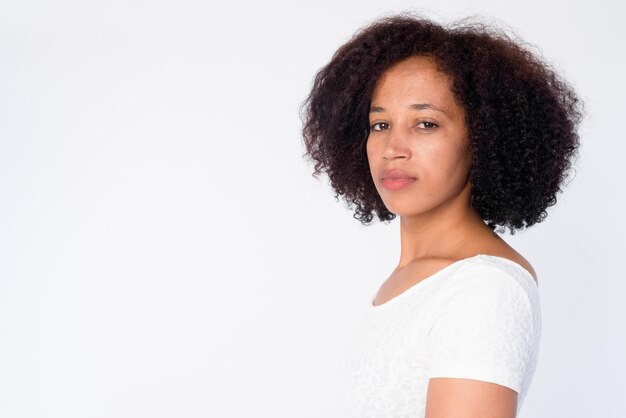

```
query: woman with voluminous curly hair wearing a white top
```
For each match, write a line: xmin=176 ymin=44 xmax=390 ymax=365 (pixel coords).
xmin=303 ymin=14 xmax=582 ymax=418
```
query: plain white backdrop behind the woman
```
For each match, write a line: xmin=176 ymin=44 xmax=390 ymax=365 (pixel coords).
xmin=0 ymin=0 xmax=626 ymax=418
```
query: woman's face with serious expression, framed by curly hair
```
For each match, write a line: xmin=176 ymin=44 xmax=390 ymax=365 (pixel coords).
xmin=367 ymin=56 xmax=471 ymax=215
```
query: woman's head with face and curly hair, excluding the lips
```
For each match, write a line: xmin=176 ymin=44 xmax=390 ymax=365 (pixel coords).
xmin=303 ymin=15 xmax=582 ymax=233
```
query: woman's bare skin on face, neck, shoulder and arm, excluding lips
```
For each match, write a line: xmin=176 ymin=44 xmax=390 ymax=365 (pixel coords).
xmin=367 ymin=56 xmax=536 ymax=418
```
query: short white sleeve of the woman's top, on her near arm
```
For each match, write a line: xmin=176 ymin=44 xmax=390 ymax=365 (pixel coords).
xmin=426 ymin=265 xmax=534 ymax=393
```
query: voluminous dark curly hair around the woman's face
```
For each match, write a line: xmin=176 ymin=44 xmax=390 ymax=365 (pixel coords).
xmin=301 ymin=13 xmax=583 ymax=234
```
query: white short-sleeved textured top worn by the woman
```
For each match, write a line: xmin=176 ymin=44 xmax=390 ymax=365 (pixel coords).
xmin=338 ymin=254 xmax=541 ymax=418
